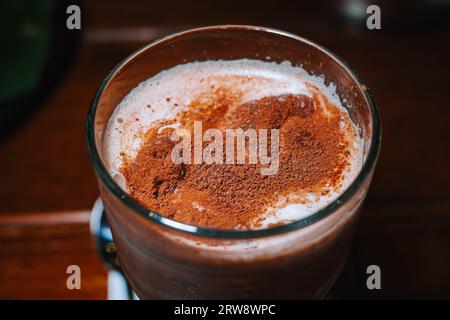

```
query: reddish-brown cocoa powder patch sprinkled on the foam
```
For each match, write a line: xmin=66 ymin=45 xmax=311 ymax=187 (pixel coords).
xmin=121 ymin=89 xmax=351 ymax=229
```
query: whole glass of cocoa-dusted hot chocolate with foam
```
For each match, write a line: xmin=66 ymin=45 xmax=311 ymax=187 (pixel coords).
xmin=87 ymin=26 xmax=380 ymax=299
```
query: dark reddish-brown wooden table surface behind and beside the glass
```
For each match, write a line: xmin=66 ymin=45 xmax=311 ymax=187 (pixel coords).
xmin=0 ymin=1 xmax=450 ymax=299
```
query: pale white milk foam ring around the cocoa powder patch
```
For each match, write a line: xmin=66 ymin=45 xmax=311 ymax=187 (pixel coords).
xmin=103 ymin=59 xmax=363 ymax=228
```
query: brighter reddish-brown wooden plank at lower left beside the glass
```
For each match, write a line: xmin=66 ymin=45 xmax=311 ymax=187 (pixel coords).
xmin=0 ymin=211 xmax=106 ymax=299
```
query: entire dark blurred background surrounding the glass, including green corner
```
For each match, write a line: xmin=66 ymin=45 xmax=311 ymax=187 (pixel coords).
xmin=0 ymin=0 xmax=450 ymax=299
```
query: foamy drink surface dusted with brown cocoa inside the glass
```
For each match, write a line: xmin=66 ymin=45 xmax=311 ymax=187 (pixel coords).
xmin=103 ymin=59 xmax=362 ymax=229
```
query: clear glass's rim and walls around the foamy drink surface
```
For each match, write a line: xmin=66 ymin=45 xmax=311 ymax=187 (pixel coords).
xmin=86 ymin=25 xmax=381 ymax=299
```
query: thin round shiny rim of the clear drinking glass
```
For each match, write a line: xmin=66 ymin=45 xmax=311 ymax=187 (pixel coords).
xmin=85 ymin=25 xmax=381 ymax=239
